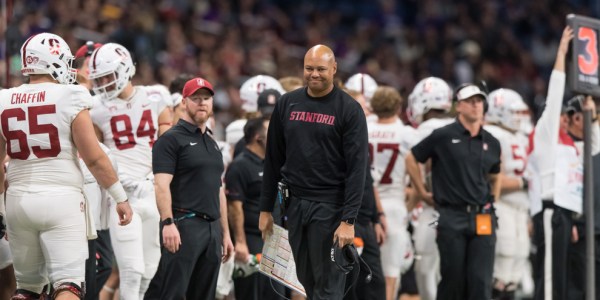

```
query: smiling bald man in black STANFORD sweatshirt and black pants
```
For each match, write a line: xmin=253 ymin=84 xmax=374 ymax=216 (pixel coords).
xmin=259 ymin=45 xmax=368 ymax=300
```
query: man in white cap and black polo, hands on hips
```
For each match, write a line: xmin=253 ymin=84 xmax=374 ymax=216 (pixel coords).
xmin=406 ymin=84 xmax=500 ymax=300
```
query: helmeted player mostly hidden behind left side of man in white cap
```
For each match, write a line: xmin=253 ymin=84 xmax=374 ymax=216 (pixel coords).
xmin=407 ymin=77 xmax=454 ymax=300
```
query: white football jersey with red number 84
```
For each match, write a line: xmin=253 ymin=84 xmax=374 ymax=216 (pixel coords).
xmin=91 ymin=86 xmax=171 ymax=181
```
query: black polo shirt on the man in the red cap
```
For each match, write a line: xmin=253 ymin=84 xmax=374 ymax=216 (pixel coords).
xmin=152 ymin=119 xmax=224 ymax=220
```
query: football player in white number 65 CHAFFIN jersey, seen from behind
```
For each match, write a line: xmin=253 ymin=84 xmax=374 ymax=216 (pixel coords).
xmin=0 ymin=33 xmax=131 ymax=299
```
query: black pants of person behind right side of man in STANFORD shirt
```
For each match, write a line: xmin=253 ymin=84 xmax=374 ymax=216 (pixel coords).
xmin=344 ymin=222 xmax=385 ymax=300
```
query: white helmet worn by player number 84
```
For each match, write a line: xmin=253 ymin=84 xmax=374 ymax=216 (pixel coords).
xmin=88 ymin=43 xmax=135 ymax=100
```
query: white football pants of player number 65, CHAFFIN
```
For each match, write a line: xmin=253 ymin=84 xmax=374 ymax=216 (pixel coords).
xmin=6 ymin=192 xmax=88 ymax=293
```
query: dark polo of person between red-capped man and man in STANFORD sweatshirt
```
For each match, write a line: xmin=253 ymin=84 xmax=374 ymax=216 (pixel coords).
xmin=225 ymin=148 xmax=264 ymax=236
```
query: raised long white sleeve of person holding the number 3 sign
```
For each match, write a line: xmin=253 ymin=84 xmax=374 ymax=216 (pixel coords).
xmin=533 ymin=70 xmax=566 ymax=198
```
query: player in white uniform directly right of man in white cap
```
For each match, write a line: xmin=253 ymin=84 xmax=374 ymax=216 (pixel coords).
xmin=484 ymin=89 xmax=530 ymax=299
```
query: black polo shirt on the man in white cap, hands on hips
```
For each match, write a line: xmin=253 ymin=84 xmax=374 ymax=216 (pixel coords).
xmin=412 ymin=119 xmax=500 ymax=206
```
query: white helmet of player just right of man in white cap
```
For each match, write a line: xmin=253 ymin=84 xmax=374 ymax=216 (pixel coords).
xmin=485 ymin=89 xmax=531 ymax=134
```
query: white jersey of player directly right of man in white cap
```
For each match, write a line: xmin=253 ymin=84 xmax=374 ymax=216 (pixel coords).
xmin=484 ymin=125 xmax=529 ymax=209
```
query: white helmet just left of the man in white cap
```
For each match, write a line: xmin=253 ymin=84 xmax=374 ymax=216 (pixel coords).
xmin=406 ymin=77 xmax=452 ymax=126
